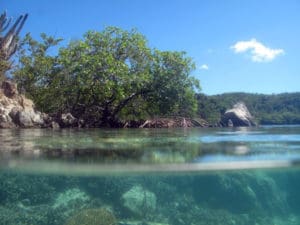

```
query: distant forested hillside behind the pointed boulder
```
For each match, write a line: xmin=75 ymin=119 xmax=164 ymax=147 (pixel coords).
xmin=196 ymin=93 xmax=300 ymax=125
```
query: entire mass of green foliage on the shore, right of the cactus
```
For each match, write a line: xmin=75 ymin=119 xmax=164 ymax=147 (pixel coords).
xmin=14 ymin=27 xmax=200 ymax=126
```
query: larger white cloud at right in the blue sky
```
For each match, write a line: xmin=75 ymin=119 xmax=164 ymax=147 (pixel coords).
xmin=230 ymin=38 xmax=284 ymax=62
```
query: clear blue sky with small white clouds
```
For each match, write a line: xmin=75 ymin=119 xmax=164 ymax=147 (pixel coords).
xmin=0 ymin=0 xmax=300 ymax=95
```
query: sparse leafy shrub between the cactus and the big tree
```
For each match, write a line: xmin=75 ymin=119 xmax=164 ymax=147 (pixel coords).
xmin=13 ymin=34 xmax=62 ymax=111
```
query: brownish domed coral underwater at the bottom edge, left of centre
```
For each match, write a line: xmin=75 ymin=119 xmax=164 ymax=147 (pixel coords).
xmin=65 ymin=208 xmax=117 ymax=225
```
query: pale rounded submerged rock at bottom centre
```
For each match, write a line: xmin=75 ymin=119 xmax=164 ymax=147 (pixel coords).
xmin=121 ymin=185 xmax=156 ymax=216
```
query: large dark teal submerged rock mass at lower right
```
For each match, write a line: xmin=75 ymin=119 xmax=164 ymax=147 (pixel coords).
xmin=191 ymin=172 xmax=288 ymax=215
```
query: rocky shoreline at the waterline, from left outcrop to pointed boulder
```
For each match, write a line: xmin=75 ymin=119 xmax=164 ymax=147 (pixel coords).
xmin=0 ymin=80 xmax=256 ymax=129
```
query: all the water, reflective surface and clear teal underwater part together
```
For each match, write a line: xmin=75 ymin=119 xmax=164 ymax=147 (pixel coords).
xmin=0 ymin=126 xmax=300 ymax=225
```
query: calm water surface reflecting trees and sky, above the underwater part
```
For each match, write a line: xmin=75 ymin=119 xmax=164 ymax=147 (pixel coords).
xmin=0 ymin=126 xmax=300 ymax=170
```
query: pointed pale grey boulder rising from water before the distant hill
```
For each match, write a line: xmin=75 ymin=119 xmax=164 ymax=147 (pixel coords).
xmin=220 ymin=102 xmax=256 ymax=127
